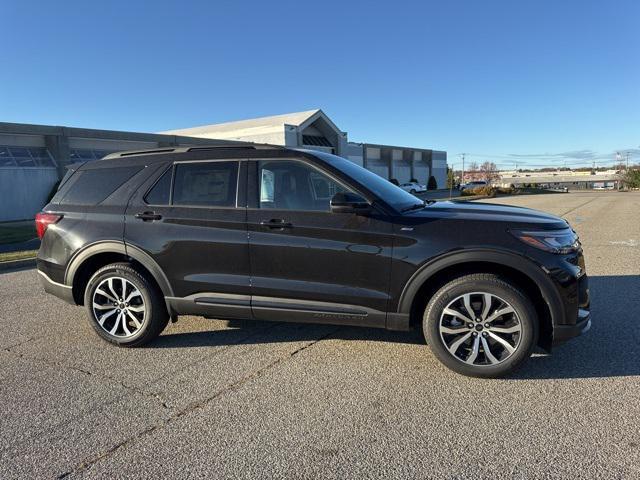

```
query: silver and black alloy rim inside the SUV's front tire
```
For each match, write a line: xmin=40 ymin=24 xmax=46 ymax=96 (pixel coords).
xmin=438 ymin=292 xmax=522 ymax=366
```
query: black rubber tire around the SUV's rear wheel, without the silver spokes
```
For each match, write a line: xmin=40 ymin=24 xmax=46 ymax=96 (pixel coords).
xmin=84 ymin=263 xmax=169 ymax=347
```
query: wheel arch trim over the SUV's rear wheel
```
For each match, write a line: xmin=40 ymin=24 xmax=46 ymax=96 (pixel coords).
xmin=65 ymin=241 xmax=173 ymax=305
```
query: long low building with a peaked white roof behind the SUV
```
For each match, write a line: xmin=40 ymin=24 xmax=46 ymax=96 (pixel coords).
xmin=0 ymin=110 xmax=447 ymax=222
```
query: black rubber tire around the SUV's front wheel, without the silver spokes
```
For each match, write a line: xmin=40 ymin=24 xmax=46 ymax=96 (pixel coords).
xmin=423 ymin=273 xmax=538 ymax=378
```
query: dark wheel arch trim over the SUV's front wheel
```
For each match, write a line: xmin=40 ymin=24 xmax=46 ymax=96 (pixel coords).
xmin=397 ymin=249 xmax=564 ymax=350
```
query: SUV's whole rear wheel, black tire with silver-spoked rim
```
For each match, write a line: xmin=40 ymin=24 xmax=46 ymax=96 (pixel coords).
xmin=84 ymin=263 xmax=169 ymax=347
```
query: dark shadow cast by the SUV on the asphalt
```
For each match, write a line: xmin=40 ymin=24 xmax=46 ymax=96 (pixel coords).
xmin=148 ymin=275 xmax=640 ymax=380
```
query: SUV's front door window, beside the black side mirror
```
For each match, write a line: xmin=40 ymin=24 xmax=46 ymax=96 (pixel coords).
xmin=258 ymin=160 xmax=349 ymax=212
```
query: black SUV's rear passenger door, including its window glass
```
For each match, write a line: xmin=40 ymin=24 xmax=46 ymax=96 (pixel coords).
xmin=125 ymin=160 xmax=251 ymax=318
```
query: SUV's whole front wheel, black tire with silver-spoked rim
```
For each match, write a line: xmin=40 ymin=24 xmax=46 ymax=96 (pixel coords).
xmin=423 ymin=274 xmax=538 ymax=378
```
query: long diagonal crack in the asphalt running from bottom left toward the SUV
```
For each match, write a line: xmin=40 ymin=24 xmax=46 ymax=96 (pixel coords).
xmin=56 ymin=327 xmax=343 ymax=479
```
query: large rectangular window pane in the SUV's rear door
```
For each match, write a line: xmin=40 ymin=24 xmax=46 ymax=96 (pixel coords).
xmin=173 ymin=162 xmax=238 ymax=207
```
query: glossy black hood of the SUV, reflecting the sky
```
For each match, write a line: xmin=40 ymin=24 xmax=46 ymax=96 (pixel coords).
xmin=406 ymin=201 xmax=569 ymax=230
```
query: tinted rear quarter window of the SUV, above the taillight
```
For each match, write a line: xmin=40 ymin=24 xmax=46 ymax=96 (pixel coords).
xmin=60 ymin=166 xmax=143 ymax=205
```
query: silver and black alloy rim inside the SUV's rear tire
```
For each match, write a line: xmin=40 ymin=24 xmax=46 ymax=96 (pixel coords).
xmin=93 ymin=277 xmax=146 ymax=338
